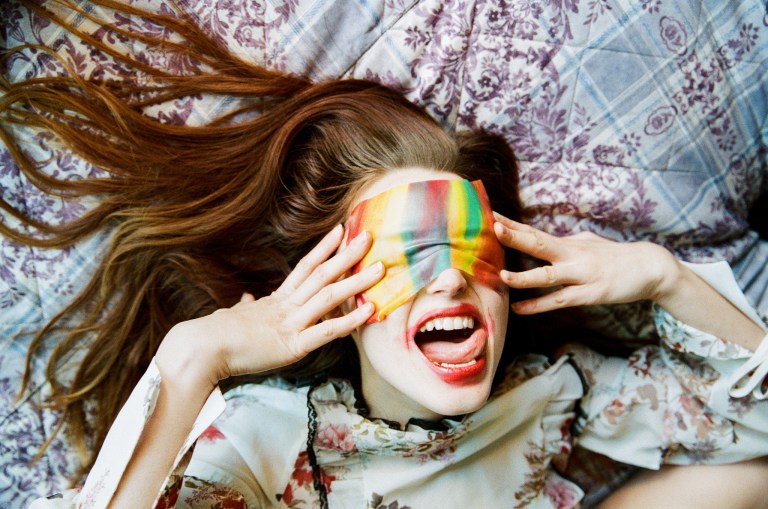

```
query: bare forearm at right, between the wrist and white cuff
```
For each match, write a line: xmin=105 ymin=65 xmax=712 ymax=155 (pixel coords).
xmin=654 ymin=260 xmax=765 ymax=351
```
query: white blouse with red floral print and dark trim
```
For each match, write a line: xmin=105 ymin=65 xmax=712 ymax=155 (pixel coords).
xmin=31 ymin=263 xmax=768 ymax=509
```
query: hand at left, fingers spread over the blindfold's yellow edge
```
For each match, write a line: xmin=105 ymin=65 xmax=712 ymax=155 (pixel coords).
xmin=155 ymin=225 xmax=384 ymax=389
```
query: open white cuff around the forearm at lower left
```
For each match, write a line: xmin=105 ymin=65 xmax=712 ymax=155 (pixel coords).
xmin=29 ymin=359 xmax=225 ymax=509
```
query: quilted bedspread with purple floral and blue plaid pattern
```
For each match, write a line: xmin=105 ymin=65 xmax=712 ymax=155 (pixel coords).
xmin=0 ymin=0 xmax=768 ymax=508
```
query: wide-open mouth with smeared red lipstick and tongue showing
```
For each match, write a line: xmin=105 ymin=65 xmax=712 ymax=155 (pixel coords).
xmin=413 ymin=304 xmax=488 ymax=381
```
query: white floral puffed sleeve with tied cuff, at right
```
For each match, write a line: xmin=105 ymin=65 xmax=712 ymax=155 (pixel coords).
xmin=570 ymin=262 xmax=768 ymax=468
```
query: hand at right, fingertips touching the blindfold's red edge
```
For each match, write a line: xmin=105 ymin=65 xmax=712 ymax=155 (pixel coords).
xmin=494 ymin=214 xmax=680 ymax=314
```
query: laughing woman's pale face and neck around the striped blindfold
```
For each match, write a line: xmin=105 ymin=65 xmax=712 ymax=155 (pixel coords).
xmin=348 ymin=168 xmax=509 ymax=423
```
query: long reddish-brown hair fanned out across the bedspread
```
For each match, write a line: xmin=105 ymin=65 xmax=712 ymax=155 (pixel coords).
xmin=0 ymin=0 xmax=520 ymax=478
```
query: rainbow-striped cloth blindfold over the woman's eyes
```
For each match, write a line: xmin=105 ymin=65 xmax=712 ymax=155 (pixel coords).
xmin=347 ymin=180 xmax=504 ymax=322
